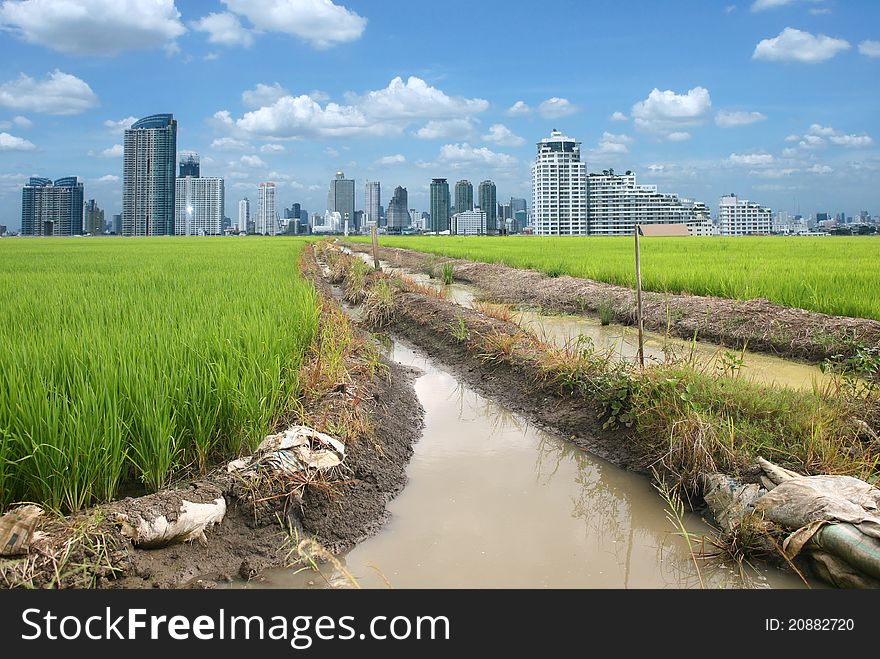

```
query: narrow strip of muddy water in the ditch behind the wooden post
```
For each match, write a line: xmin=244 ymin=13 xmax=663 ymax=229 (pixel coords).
xmin=360 ymin=254 xmax=831 ymax=390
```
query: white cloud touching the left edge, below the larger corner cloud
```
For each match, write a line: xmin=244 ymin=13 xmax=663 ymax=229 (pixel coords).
xmin=0 ymin=69 xmax=98 ymax=114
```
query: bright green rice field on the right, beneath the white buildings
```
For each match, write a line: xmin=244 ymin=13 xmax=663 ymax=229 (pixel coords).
xmin=358 ymin=236 xmax=880 ymax=320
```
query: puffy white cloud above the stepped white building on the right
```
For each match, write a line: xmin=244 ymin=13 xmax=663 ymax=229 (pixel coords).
xmin=632 ymin=87 xmax=712 ymax=141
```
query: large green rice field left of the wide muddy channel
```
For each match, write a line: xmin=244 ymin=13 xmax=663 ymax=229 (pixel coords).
xmin=0 ymin=238 xmax=319 ymax=511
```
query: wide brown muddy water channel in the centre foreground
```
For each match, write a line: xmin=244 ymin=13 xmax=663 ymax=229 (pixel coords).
xmin=241 ymin=344 xmax=803 ymax=588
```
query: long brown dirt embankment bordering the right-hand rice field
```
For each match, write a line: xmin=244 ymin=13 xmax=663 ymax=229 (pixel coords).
xmin=350 ymin=244 xmax=880 ymax=363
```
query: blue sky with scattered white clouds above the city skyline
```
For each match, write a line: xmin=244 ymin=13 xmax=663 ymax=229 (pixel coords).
xmin=0 ymin=0 xmax=880 ymax=227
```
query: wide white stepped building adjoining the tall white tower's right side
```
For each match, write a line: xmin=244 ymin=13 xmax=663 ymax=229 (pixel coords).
xmin=587 ymin=169 xmax=712 ymax=236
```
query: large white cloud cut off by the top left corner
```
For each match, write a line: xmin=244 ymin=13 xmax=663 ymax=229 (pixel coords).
xmin=0 ymin=0 xmax=186 ymax=55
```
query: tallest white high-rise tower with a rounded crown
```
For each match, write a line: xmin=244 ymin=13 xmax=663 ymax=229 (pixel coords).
xmin=532 ymin=130 xmax=589 ymax=236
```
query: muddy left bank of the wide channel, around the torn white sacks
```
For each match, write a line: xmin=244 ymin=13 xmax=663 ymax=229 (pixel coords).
xmin=0 ymin=253 xmax=423 ymax=588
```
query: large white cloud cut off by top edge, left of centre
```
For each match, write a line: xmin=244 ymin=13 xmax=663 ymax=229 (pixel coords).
xmin=223 ymin=0 xmax=367 ymax=48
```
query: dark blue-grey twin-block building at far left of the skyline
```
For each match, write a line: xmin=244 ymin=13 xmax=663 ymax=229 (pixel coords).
xmin=21 ymin=176 xmax=83 ymax=236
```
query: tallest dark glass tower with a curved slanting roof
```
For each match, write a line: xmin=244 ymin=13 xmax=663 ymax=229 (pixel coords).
xmin=122 ymin=114 xmax=177 ymax=236
